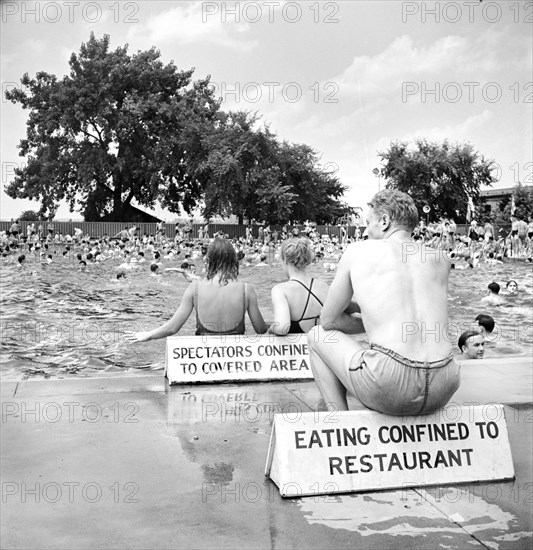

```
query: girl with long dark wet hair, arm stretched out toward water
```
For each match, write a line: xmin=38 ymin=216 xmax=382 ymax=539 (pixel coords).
xmin=126 ymin=239 xmax=268 ymax=343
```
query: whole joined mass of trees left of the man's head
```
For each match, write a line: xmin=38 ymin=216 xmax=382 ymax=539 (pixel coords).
xmin=6 ymin=34 xmax=352 ymax=223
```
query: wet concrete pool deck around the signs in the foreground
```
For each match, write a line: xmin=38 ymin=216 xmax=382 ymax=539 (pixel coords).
xmin=0 ymin=357 xmax=533 ymax=549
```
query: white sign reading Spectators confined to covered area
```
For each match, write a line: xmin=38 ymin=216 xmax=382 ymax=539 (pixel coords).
xmin=165 ymin=334 xmax=313 ymax=384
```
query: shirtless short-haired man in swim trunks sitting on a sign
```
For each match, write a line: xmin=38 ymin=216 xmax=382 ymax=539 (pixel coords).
xmin=308 ymin=189 xmax=460 ymax=415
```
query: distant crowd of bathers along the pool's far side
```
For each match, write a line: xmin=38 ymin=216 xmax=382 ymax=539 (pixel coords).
xmin=4 ymin=216 xmax=533 ymax=271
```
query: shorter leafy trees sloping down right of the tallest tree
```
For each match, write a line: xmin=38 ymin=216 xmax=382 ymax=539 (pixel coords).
xmin=196 ymin=111 xmax=349 ymax=223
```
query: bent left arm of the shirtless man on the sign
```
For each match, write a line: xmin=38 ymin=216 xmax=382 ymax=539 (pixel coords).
xmin=320 ymin=247 xmax=364 ymax=334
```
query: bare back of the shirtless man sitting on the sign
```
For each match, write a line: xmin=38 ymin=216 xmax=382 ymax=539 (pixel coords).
xmin=344 ymin=240 xmax=451 ymax=361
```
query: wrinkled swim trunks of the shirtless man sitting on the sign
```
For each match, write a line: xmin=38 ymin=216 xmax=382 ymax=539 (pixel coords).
xmin=348 ymin=344 xmax=460 ymax=416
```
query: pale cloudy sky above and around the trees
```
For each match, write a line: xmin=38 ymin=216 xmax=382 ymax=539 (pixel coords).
xmin=0 ymin=0 xmax=533 ymax=220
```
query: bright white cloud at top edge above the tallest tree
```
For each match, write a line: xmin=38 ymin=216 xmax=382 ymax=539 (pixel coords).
xmin=128 ymin=2 xmax=258 ymax=51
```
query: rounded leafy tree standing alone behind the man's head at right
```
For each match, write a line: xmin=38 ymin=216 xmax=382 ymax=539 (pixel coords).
xmin=378 ymin=139 xmax=496 ymax=223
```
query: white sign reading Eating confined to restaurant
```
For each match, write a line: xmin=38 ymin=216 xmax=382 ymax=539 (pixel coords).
xmin=265 ymin=405 xmax=514 ymax=497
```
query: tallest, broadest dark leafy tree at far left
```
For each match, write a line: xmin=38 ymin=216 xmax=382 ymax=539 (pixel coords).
xmin=6 ymin=34 xmax=220 ymax=219
